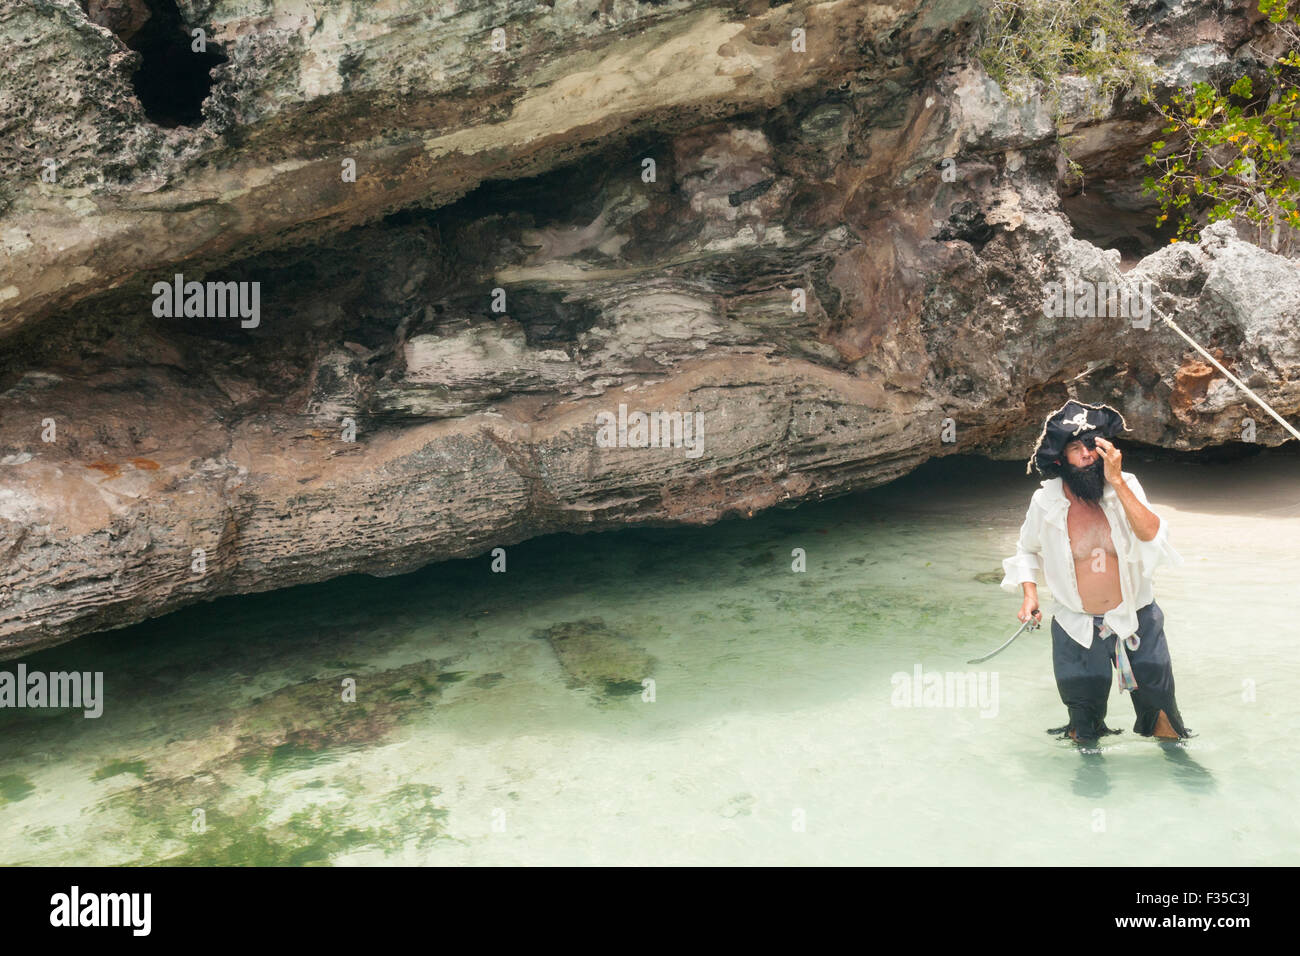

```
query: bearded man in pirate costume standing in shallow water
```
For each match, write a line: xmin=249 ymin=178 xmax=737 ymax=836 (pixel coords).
xmin=1002 ymin=401 xmax=1191 ymax=747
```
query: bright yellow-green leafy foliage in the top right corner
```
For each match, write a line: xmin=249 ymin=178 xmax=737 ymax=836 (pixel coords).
xmin=1144 ymin=0 xmax=1300 ymax=251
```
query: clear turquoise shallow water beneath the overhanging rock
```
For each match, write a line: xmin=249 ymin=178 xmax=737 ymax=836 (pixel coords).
xmin=0 ymin=454 xmax=1300 ymax=865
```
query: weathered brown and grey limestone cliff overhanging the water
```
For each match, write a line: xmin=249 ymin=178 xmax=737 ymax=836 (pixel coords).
xmin=0 ymin=0 xmax=1300 ymax=656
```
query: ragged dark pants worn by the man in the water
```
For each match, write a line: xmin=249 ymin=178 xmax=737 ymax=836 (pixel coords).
xmin=1050 ymin=601 xmax=1191 ymax=739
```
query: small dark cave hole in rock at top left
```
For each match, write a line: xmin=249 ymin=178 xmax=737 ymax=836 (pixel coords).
xmin=126 ymin=0 xmax=226 ymax=129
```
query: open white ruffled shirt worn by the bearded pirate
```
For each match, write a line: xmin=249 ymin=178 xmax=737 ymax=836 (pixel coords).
xmin=1001 ymin=471 xmax=1183 ymax=648
